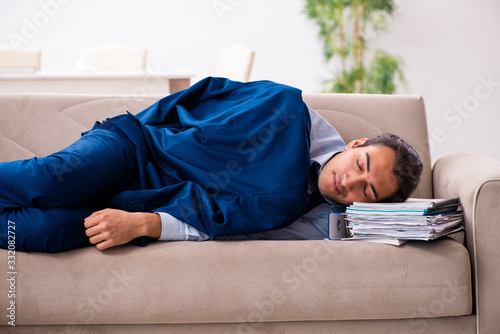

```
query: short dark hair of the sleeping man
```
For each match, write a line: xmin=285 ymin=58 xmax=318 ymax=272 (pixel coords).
xmin=358 ymin=133 xmax=423 ymax=202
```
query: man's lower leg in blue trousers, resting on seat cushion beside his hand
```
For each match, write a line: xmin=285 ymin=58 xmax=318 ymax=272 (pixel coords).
xmin=0 ymin=207 xmax=102 ymax=253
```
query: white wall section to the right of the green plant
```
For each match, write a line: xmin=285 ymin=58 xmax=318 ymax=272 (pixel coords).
xmin=377 ymin=0 xmax=500 ymax=164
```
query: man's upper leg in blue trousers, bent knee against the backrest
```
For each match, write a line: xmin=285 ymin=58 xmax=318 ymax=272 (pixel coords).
xmin=0 ymin=129 xmax=137 ymax=213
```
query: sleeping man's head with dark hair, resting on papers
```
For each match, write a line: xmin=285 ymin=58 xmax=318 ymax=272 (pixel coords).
xmin=318 ymin=134 xmax=423 ymax=205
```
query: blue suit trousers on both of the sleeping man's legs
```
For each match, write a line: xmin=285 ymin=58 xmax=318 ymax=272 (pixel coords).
xmin=0 ymin=129 xmax=141 ymax=252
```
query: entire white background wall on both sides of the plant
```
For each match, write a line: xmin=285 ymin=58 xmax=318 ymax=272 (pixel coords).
xmin=0 ymin=0 xmax=500 ymax=161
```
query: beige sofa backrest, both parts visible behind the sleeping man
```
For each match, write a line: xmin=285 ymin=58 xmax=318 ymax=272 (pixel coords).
xmin=0 ymin=94 xmax=432 ymax=198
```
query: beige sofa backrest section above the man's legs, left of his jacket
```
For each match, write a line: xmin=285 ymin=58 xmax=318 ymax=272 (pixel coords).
xmin=0 ymin=94 xmax=162 ymax=161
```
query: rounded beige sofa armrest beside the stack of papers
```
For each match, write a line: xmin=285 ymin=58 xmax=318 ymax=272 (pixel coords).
xmin=433 ymin=154 xmax=500 ymax=333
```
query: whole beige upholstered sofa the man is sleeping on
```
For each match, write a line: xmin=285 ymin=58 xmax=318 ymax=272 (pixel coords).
xmin=0 ymin=90 xmax=500 ymax=333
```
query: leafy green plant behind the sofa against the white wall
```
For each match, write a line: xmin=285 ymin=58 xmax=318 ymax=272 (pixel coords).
xmin=305 ymin=0 xmax=405 ymax=94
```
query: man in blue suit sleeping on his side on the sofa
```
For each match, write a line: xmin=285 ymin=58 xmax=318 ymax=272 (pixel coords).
xmin=0 ymin=78 xmax=422 ymax=252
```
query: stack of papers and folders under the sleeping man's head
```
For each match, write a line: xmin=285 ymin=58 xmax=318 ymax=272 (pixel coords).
xmin=345 ymin=198 xmax=464 ymax=244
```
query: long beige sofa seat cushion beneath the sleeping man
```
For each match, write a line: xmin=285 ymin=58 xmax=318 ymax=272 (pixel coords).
xmin=0 ymin=238 xmax=472 ymax=325
